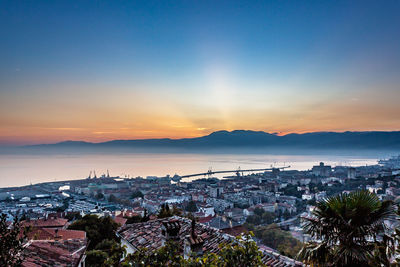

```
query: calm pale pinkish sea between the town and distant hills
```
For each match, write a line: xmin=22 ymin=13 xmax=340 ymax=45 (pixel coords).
xmin=0 ymin=153 xmax=389 ymax=187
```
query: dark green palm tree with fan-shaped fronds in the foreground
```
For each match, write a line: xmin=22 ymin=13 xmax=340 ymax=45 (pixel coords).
xmin=298 ymin=191 xmax=395 ymax=267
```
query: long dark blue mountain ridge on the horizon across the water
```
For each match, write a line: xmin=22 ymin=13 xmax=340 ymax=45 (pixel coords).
xmin=25 ymin=130 xmax=400 ymax=151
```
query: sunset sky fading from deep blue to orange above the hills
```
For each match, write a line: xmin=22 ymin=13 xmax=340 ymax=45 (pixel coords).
xmin=0 ymin=0 xmax=400 ymax=145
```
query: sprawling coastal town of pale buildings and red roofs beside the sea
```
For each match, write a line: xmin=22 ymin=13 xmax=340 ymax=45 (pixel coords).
xmin=0 ymin=158 xmax=400 ymax=266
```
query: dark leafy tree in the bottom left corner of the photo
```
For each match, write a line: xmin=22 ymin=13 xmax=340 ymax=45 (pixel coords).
xmin=0 ymin=213 xmax=28 ymax=267
